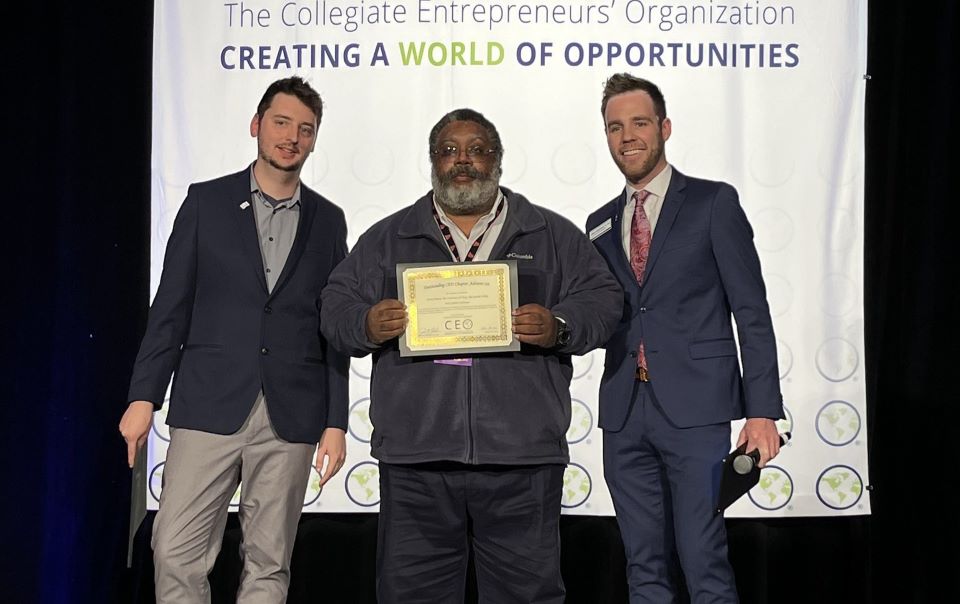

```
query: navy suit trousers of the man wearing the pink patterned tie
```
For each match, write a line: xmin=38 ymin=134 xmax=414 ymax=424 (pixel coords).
xmin=603 ymin=382 xmax=738 ymax=604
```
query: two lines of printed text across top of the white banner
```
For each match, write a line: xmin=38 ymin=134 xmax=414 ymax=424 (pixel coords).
xmin=218 ymin=0 xmax=802 ymax=70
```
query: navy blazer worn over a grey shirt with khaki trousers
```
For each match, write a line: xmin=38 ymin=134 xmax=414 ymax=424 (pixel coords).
xmin=128 ymin=168 xmax=348 ymax=443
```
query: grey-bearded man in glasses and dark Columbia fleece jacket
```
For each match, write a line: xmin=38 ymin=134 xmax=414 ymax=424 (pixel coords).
xmin=321 ymin=109 xmax=623 ymax=604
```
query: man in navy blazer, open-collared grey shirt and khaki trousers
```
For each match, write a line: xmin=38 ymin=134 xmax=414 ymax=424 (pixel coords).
xmin=120 ymin=77 xmax=348 ymax=604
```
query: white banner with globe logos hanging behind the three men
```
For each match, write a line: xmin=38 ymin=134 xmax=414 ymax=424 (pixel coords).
xmin=147 ymin=0 xmax=870 ymax=517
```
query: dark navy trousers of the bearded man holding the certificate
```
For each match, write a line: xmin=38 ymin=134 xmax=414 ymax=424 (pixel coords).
xmin=377 ymin=462 xmax=565 ymax=604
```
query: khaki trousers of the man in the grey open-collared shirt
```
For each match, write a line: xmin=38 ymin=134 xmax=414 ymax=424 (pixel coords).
xmin=152 ymin=394 xmax=315 ymax=604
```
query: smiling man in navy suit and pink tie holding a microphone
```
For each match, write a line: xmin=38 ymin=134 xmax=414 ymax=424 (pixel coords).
xmin=587 ymin=73 xmax=783 ymax=604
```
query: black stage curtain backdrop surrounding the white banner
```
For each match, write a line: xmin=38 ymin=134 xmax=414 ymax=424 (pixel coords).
xmin=0 ymin=0 xmax=960 ymax=604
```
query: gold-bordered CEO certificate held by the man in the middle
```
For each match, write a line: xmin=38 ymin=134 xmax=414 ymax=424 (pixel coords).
xmin=397 ymin=260 xmax=520 ymax=356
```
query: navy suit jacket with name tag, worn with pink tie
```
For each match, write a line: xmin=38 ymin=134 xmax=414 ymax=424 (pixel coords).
xmin=587 ymin=169 xmax=783 ymax=430
